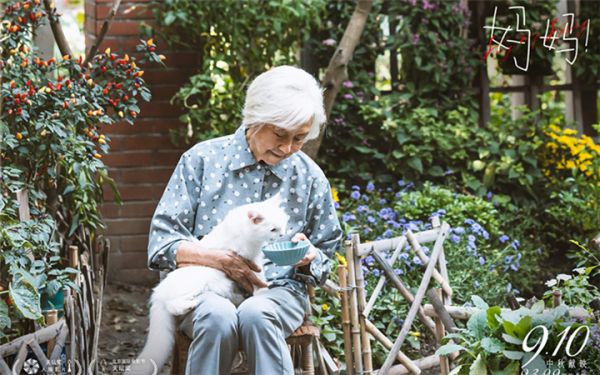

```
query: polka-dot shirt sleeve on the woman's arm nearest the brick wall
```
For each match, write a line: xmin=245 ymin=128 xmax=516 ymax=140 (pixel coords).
xmin=148 ymin=148 xmax=203 ymax=270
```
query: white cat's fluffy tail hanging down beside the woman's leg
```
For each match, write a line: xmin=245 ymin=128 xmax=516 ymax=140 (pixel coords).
xmin=128 ymin=298 xmax=176 ymax=375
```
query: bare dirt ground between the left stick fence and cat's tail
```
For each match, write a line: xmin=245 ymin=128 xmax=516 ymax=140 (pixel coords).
xmin=98 ymin=284 xmax=171 ymax=375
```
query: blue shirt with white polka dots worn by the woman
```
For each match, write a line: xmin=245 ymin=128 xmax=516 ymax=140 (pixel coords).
xmin=148 ymin=127 xmax=342 ymax=292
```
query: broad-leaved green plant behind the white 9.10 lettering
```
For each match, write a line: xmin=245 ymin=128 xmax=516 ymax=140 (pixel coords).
xmin=436 ymin=296 xmax=589 ymax=375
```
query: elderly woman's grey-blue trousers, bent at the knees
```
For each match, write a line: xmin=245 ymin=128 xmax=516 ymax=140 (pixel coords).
xmin=181 ymin=287 xmax=308 ymax=375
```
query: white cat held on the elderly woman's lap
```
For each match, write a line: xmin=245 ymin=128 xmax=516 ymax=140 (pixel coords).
xmin=128 ymin=194 xmax=288 ymax=374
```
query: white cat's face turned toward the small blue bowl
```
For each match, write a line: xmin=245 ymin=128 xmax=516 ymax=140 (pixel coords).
xmin=247 ymin=194 xmax=289 ymax=242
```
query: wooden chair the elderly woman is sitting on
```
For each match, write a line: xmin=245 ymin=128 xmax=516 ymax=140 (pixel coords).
xmin=171 ymin=285 xmax=327 ymax=375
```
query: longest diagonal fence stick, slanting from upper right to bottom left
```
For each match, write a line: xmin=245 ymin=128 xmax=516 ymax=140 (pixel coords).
xmin=380 ymin=223 xmax=450 ymax=374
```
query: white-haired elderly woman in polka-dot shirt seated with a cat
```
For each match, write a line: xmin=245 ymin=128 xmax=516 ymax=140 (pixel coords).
xmin=148 ymin=66 xmax=342 ymax=375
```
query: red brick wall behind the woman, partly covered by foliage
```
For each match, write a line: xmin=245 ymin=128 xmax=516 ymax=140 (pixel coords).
xmin=85 ymin=0 xmax=197 ymax=285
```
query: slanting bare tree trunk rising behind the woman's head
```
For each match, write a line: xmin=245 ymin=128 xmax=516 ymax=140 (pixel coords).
xmin=302 ymin=0 xmax=373 ymax=159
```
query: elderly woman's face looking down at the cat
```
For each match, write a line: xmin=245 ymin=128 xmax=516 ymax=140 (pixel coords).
xmin=246 ymin=124 xmax=311 ymax=165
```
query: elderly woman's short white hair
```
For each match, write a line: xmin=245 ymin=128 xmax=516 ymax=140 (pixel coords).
xmin=242 ymin=65 xmax=327 ymax=140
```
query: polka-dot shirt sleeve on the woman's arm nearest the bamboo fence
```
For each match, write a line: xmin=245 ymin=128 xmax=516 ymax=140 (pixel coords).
xmin=306 ymin=178 xmax=342 ymax=285
